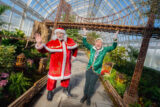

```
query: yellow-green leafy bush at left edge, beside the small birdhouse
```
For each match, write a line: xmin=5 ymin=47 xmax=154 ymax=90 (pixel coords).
xmin=0 ymin=45 xmax=16 ymax=72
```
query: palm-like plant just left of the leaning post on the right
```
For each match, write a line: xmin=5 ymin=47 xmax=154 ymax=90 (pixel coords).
xmin=128 ymin=46 xmax=139 ymax=62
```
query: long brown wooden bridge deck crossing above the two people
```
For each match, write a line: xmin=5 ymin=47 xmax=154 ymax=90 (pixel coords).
xmin=44 ymin=21 xmax=160 ymax=35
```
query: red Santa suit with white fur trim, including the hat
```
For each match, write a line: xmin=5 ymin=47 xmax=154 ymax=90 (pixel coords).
xmin=35 ymin=28 xmax=78 ymax=91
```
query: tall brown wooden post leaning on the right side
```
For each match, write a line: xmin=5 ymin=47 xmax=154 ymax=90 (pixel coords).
xmin=124 ymin=14 xmax=155 ymax=104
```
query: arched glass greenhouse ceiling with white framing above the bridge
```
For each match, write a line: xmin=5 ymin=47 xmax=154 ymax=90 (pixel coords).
xmin=0 ymin=0 xmax=160 ymax=35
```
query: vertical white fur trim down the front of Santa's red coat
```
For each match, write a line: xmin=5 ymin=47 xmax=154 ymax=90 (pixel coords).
xmin=61 ymin=41 xmax=67 ymax=79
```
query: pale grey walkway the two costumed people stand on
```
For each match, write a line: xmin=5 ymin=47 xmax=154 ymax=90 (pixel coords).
xmin=27 ymin=51 xmax=114 ymax=107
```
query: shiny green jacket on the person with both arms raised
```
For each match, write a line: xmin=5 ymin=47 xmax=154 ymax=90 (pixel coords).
xmin=83 ymin=37 xmax=117 ymax=74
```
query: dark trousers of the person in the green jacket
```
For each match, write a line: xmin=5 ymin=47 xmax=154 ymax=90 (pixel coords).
xmin=84 ymin=68 xmax=99 ymax=98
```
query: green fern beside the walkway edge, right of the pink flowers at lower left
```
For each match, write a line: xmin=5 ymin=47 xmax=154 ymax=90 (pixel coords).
xmin=9 ymin=73 xmax=31 ymax=98
